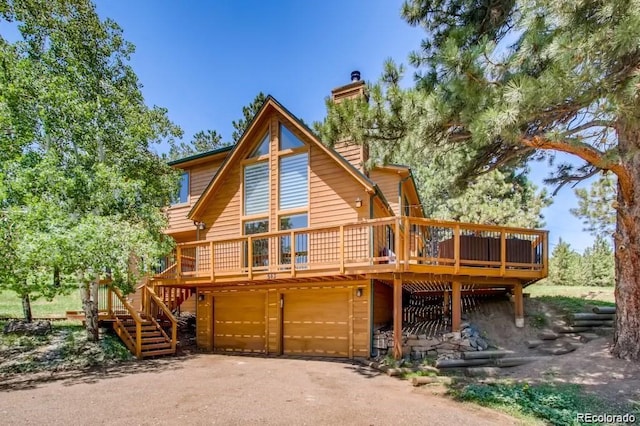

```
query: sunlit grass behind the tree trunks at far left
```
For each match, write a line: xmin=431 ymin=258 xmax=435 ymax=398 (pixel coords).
xmin=0 ymin=290 xmax=82 ymax=318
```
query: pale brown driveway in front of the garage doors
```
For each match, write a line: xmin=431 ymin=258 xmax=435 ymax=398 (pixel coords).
xmin=0 ymin=355 xmax=514 ymax=425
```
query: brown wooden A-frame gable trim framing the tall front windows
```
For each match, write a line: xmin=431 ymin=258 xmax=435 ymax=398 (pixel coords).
xmin=188 ymin=95 xmax=376 ymax=220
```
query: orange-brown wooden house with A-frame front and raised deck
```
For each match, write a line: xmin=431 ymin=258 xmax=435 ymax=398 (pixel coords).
xmin=99 ymin=75 xmax=548 ymax=358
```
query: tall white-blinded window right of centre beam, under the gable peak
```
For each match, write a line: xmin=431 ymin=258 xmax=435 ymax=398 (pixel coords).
xmin=280 ymin=152 xmax=309 ymax=210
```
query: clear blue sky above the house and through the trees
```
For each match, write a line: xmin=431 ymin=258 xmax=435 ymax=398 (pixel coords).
xmin=91 ymin=0 xmax=592 ymax=251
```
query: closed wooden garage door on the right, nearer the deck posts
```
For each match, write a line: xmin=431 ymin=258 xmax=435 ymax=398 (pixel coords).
xmin=282 ymin=290 xmax=349 ymax=357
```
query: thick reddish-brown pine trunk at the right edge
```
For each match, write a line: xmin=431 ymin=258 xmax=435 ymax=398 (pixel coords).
xmin=612 ymin=120 xmax=640 ymax=361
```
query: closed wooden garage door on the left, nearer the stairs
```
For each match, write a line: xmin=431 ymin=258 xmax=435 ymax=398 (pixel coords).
xmin=213 ymin=292 xmax=266 ymax=352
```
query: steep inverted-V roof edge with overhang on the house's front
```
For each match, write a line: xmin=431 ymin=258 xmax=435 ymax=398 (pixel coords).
xmin=188 ymin=95 xmax=389 ymax=219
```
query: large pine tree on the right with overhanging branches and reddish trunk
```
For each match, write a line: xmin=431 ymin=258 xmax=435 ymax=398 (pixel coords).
xmin=328 ymin=0 xmax=640 ymax=360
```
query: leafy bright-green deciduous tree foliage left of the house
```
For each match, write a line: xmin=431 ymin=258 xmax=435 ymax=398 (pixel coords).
xmin=0 ymin=0 xmax=181 ymax=330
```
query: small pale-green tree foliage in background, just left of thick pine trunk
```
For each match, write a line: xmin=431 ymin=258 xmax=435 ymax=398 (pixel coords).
xmin=571 ymin=174 xmax=617 ymax=238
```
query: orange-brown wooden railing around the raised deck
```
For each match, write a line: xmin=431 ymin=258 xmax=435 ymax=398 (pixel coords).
xmin=154 ymin=217 xmax=548 ymax=282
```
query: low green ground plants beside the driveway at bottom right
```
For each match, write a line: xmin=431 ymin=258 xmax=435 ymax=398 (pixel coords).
xmin=454 ymin=383 xmax=602 ymax=425
